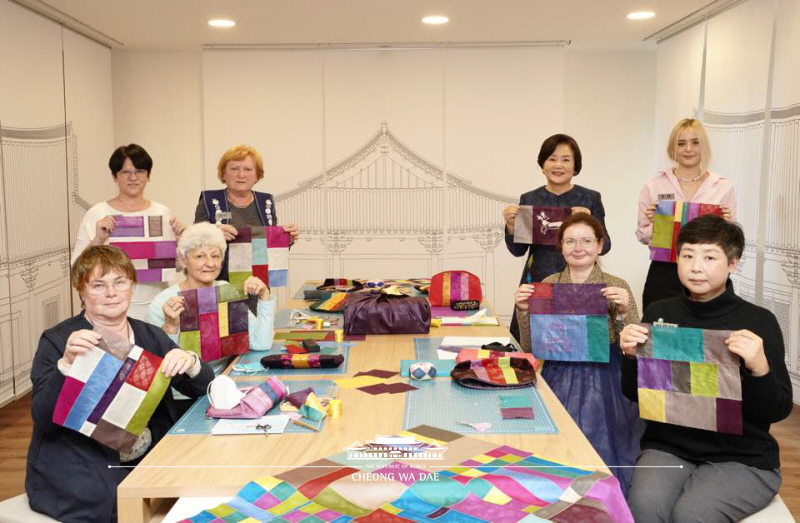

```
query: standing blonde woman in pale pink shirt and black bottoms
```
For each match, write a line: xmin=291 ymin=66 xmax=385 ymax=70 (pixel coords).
xmin=636 ymin=118 xmax=736 ymax=309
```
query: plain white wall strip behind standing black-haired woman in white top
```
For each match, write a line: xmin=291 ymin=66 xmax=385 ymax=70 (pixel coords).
xmin=112 ymin=50 xmax=206 ymax=223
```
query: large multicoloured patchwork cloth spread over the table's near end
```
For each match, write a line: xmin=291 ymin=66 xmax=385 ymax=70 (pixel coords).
xmin=185 ymin=426 xmax=633 ymax=523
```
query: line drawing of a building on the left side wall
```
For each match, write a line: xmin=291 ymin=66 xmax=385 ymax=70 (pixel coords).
xmin=0 ymin=124 xmax=75 ymax=403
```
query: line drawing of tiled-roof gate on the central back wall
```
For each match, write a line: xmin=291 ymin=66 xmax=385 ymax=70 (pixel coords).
xmin=275 ymin=121 xmax=518 ymax=312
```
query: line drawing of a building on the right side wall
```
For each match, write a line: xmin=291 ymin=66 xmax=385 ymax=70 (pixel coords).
xmin=704 ymin=105 xmax=800 ymax=396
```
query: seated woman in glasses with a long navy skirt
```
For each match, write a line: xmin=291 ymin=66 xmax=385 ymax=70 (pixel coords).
xmin=514 ymin=212 xmax=643 ymax=492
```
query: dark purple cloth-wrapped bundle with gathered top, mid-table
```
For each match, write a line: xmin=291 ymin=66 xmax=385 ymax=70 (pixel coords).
xmin=344 ymin=292 xmax=431 ymax=334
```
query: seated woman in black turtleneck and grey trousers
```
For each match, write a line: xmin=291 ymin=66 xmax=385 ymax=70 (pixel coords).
xmin=620 ymin=216 xmax=792 ymax=522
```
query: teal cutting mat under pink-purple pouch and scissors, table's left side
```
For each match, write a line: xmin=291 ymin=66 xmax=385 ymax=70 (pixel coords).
xmin=167 ymin=379 xmax=336 ymax=436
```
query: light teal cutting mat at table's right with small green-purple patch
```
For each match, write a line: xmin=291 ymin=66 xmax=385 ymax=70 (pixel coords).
xmin=403 ymin=379 xmax=558 ymax=434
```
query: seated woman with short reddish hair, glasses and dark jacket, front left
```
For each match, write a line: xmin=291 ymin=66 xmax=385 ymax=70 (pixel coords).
xmin=25 ymin=245 xmax=214 ymax=521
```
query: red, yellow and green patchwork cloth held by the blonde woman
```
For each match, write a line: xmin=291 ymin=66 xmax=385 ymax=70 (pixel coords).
xmin=650 ymin=200 xmax=722 ymax=262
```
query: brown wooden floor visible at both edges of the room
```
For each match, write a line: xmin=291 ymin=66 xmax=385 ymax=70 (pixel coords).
xmin=0 ymin=395 xmax=800 ymax=519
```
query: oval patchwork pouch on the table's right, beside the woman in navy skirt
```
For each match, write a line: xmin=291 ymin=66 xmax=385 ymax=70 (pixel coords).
xmin=450 ymin=357 xmax=536 ymax=389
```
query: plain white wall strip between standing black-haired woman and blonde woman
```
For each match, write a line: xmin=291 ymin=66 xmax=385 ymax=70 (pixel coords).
xmin=564 ymin=45 xmax=659 ymax=312
